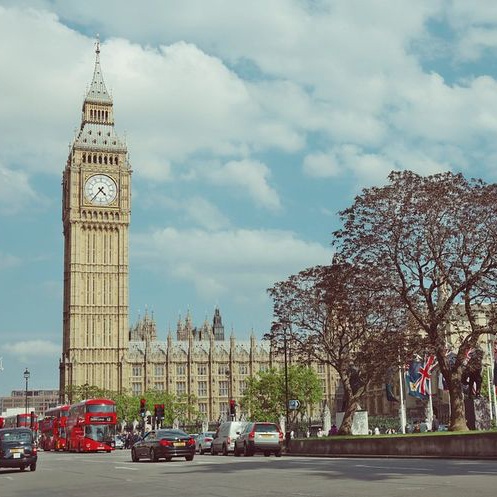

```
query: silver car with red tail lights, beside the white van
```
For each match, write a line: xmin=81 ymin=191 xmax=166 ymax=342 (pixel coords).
xmin=234 ymin=423 xmax=283 ymax=457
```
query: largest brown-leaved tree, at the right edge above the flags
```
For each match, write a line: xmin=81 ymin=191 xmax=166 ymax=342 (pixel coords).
xmin=333 ymin=171 xmax=497 ymax=431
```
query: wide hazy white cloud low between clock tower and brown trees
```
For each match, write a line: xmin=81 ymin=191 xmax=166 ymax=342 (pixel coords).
xmin=132 ymin=228 xmax=332 ymax=301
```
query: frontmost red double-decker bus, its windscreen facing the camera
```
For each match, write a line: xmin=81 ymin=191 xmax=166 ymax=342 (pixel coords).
xmin=66 ymin=399 xmax=117 ymax=452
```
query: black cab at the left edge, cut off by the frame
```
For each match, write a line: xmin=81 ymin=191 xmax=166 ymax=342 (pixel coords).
xmin=0 ymin=428 xmax=38 ymax=471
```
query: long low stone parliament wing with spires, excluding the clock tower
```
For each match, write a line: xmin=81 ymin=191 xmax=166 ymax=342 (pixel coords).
xmin=127 ymin=307 xmax=338 ymax=421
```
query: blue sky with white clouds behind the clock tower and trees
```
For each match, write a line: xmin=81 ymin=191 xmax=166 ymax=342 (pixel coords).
xmin=0 ymin=0 xmax=497 ymax=395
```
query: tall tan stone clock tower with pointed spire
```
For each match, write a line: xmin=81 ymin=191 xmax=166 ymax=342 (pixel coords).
xmin=60 ymin=41 xmax=131 ymax=401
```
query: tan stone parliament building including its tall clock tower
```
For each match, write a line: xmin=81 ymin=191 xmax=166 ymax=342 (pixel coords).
xmin=59 ymin=41 xmax=336 ymax=420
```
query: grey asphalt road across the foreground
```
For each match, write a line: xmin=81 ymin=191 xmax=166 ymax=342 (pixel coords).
xmin=0 ymin=450 xmax=497 ymax=497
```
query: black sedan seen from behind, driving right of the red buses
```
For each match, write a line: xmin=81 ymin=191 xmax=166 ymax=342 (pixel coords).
xmin=131 ymin=428 xmax=195 ymax=462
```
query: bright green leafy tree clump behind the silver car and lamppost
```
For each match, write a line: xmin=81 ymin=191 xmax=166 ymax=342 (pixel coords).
xmin=240 ymin=364 xmax=323 ymax=423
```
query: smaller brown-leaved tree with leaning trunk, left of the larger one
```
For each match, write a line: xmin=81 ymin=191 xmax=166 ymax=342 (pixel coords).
xmin=268 ymin=257 xmax=405 ymax=434
